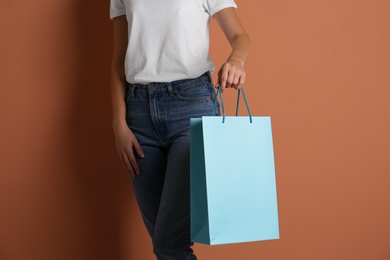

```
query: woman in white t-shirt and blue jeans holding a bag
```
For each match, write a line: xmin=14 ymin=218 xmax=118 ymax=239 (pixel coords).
xmin=110 ymin=0 xmax=250 ymax=260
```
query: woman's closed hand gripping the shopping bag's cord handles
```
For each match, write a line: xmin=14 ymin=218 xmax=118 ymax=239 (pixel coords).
xmin=218 ymin=58 xmax=246 ymax=91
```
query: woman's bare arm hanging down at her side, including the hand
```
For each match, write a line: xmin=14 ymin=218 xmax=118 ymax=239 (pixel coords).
xmin=111 ymin=15 xmax=144 ymax=177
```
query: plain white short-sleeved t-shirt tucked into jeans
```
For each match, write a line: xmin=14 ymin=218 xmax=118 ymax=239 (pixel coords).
xmin=110 ymin=0 xmax=237 ymax=84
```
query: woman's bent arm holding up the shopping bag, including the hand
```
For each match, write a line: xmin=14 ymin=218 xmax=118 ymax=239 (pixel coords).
xmin=214 ymin=8 xmax=250 ymax=90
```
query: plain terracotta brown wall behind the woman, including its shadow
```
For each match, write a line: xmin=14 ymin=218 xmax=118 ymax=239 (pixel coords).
xmin=0 ymin=0 xmax=390 ymax=260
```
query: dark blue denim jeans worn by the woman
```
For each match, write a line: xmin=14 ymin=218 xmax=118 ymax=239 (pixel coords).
xmin=125 ymin=72 xmax=219 ymax=260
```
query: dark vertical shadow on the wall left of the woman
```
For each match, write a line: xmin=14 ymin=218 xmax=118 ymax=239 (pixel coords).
xmin=66 ymin=0 xmax=148 ymax=260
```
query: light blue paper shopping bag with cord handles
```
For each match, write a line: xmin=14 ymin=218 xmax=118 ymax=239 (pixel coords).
xmin=191 ymin=89 xmax=279 ymax=245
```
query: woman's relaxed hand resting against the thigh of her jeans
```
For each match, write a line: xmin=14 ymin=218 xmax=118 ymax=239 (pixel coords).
xmin=113 ymin=122 xmax=144 ymax=178
